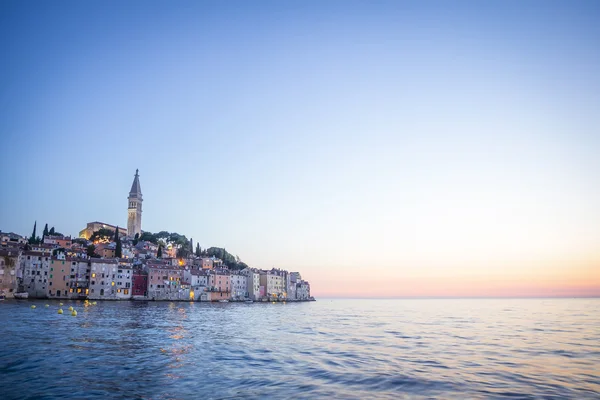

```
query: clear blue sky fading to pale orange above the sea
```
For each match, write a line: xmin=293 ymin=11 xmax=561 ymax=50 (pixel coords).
xmin=0 ymin=0 xmax=600 ymax=297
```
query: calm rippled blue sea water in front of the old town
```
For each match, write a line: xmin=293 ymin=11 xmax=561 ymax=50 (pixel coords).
xmin=0 ymin=299 xmax=600 ymax=400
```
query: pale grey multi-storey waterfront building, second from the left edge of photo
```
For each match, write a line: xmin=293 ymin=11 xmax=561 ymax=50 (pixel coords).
xmin=17 ymin=251 xmax=50 ymax=298
